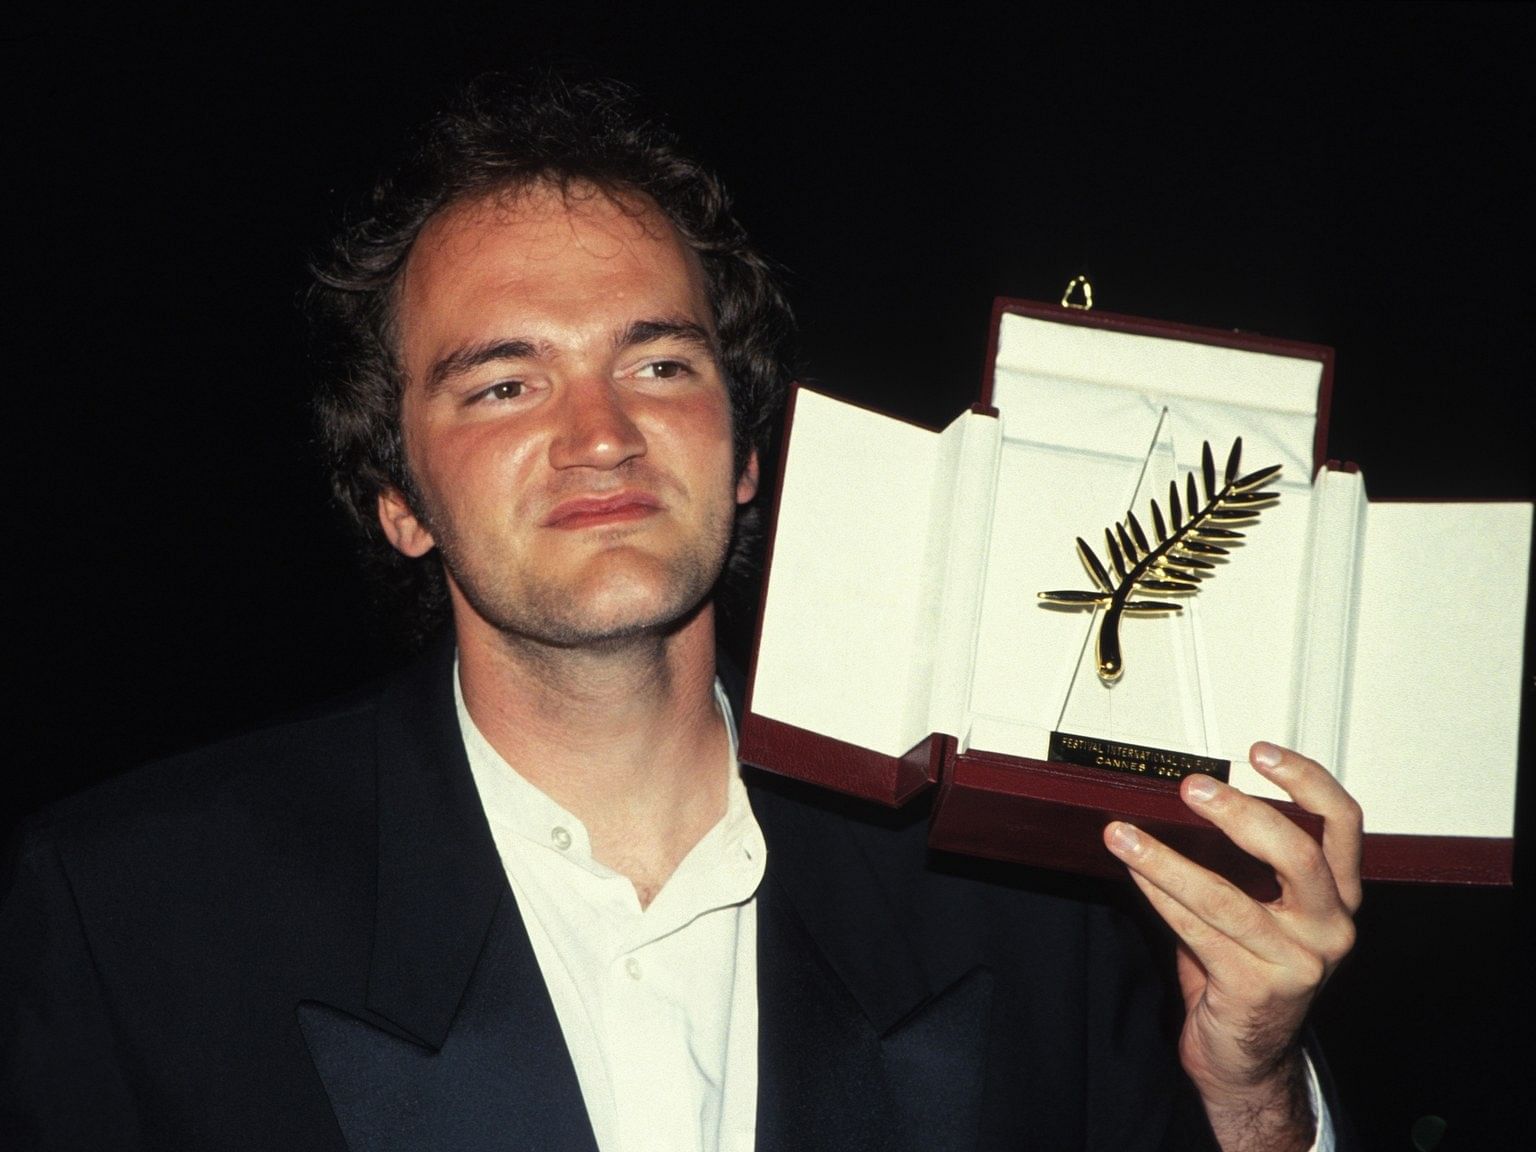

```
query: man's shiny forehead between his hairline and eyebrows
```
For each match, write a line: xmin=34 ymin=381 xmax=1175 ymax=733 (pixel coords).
xmin=396 ymin=184 xmax=714 ymax=366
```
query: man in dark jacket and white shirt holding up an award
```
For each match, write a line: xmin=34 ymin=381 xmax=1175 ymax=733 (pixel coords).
xmin=0 ymin=76 xmax=1359 ymax=1152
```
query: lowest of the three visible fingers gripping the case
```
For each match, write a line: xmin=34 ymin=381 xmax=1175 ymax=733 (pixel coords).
xmin=1104 ymin=817 xmax=1299 ymax=968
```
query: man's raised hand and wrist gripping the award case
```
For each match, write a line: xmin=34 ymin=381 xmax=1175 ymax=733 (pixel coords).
xmin=1104 ymin=743 xmax=1361 ymax=1149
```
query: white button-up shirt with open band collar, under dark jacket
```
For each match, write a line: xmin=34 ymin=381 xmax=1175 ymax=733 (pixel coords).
xmin=453 ymin=668 xmax=1333 ymax=1152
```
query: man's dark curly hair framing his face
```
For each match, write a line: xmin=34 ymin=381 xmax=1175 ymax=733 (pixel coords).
xmin=306 ymin=75 xmax=794 ymax=639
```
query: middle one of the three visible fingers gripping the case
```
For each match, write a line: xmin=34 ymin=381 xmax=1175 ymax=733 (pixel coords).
xmin=1180 ymin=776 xmax=1342 ymax=915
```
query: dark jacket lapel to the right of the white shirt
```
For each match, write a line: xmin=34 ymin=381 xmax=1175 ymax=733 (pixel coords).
xmin=748 ymin=774 xmax=991 ymax=1152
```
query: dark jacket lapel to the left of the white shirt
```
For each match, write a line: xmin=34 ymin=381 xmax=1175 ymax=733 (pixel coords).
xmin=298 ymin=645 xmax=596 ymax=1152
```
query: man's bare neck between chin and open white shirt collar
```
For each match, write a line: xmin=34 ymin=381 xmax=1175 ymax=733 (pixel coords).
xmin=456 ymin=604 xmax=730 ymax=905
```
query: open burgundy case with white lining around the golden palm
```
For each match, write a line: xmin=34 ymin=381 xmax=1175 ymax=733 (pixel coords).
xmin=740 ymin=300 xmax=1530 ymax=895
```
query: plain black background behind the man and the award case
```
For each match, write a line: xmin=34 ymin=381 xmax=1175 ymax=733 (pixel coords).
xmin=0 ymin=3 xmax=1536 ymax=1149
